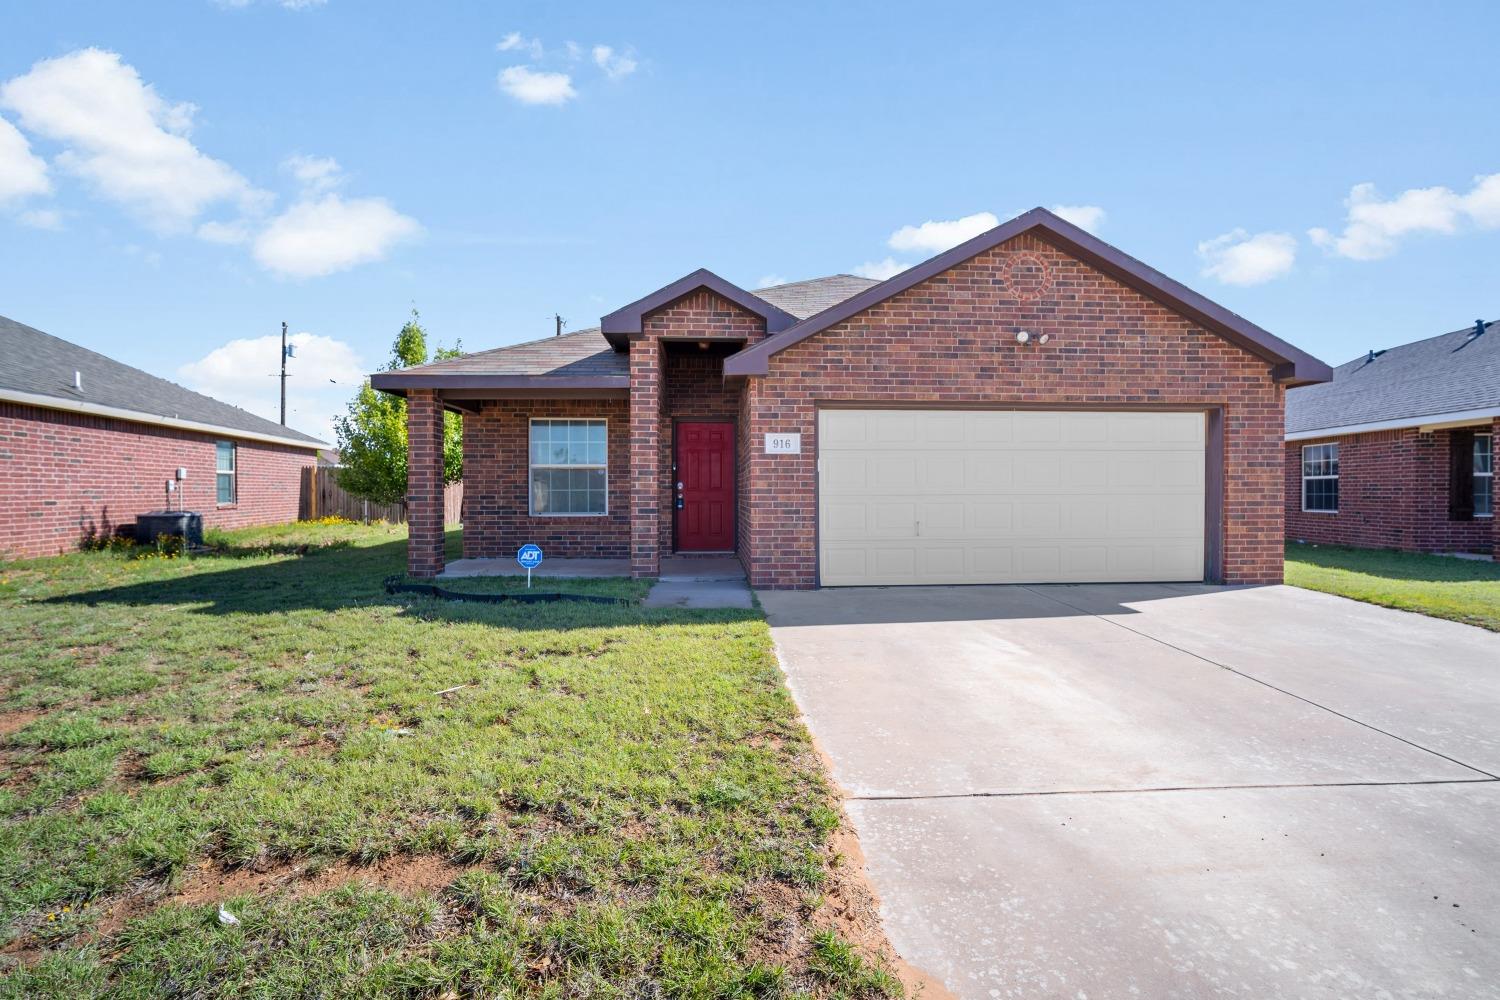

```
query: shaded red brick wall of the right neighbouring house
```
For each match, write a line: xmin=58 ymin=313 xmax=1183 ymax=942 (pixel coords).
xmin=1286 ymin=420 xmax=1500 ymax=552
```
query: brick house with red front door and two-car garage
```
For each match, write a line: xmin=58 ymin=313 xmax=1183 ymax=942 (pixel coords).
xmin=371 ymin=208 xmax=1329 ymax=588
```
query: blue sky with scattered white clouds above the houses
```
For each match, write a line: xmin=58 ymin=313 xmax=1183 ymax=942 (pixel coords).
xmin=0 ymin=0 xmax=1500 ymax=441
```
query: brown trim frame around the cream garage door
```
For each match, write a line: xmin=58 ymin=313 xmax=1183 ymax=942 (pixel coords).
xmin=813 ymin=399 xmax=1224 ymax=586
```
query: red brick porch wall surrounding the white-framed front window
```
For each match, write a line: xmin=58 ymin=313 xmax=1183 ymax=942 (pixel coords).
xmin=464 ymin=399 xmax=630 ymax=559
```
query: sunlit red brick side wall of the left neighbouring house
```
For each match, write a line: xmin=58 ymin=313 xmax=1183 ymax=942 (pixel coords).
xmin=0 ymin=403 xmax=317 ymax=558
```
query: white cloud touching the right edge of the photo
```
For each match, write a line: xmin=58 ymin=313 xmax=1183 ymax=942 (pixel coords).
xmin=1308 ymin=174 xmax=1500 ymax=261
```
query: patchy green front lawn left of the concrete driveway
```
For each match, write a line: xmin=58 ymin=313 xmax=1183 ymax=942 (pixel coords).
xmin=0 ymin=525 xmax=900 ymax=999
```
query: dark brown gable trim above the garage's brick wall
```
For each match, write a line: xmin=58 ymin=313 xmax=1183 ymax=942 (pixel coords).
xmin=725 ymin=208 xmax=1332 ymax=385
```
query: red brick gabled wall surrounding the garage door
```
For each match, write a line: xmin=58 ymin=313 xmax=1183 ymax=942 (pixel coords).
xmin=741 ymin=234 xmax=1284 ymax=588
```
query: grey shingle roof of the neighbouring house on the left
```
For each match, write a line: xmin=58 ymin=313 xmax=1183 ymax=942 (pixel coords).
xmin=0 ymin=316 xmax=324 ymax=448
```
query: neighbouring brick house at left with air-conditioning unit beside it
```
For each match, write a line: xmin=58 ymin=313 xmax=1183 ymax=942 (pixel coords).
xmin=0 ymin=316 xmax=326 ymax=558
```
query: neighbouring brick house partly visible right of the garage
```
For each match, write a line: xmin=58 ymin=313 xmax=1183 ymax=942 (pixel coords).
xmin=1286 ymin=321 xmax=1500 ymax=553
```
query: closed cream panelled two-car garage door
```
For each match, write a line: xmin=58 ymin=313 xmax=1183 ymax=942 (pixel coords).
xmin=818 ymin=409 xmax=1205 ymax=586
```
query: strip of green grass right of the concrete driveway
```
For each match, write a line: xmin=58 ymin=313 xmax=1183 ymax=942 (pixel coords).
xmin=1287 ymin=544 xmax=1500 ymax=631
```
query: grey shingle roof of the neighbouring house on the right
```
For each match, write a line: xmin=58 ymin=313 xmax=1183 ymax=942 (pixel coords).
xmin=1287 ymin=322 xmax=1500 ymax=436
